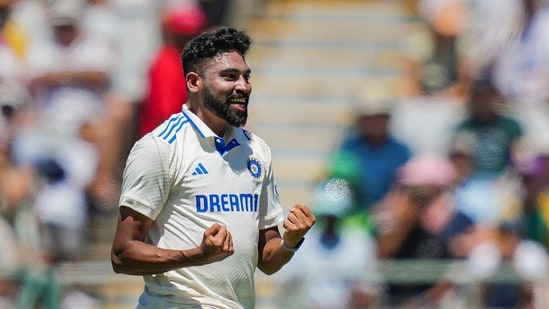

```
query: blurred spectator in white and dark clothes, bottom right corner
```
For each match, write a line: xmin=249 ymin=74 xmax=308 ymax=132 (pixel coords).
xmin=450 ymin=215 xmax=549 ymax=308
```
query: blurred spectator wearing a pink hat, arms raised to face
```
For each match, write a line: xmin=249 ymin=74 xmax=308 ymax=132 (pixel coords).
xmin=372 ymin=154 xmax=474 ymax=308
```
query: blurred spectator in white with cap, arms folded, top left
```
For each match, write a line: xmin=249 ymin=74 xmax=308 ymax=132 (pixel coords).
xmin=26 ymin=0 xmax=114 ymax=119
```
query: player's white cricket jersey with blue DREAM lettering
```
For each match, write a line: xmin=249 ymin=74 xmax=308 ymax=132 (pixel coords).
xmin=120 ymin=107 xmax=284 ymax=309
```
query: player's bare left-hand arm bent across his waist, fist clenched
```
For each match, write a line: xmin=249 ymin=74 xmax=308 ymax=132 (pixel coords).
xmin=111 ymin=206 xmax=234 ymax=275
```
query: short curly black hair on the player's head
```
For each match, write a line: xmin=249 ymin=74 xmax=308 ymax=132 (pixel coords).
xmin=181 ymin=27 xmax=252 ymax=75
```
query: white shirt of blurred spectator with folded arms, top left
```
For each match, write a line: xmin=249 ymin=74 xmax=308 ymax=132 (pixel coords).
xmin=25 ymin=31 xmax=116 ymax=136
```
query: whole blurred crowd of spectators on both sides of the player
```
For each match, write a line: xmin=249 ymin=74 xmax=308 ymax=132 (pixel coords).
xmin=0 ymin=0 xmax=549 ymax=309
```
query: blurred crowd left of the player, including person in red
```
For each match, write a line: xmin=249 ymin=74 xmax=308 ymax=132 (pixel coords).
xmin=0 ymin=0 xmax=230 ymax=309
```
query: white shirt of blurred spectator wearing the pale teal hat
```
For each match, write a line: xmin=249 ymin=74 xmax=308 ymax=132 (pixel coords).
xmin=274 ymin=222 xmax=380 ymax=309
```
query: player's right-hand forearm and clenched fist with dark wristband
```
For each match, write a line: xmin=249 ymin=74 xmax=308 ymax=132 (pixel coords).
xmin=258 ymin=204 xmax=316 ymax=275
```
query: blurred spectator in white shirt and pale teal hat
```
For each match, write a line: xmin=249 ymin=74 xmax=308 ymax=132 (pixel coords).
xmin=277 ymin=174 xmax=382 ymax=309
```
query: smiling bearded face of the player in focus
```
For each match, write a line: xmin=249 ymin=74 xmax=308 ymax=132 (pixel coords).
xmin=202 ymin=52 xmax=252 ymax=127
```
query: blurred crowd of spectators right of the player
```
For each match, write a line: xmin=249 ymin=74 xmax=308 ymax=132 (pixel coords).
xmin=281 ymin=0 xmax=549 ymax=309
